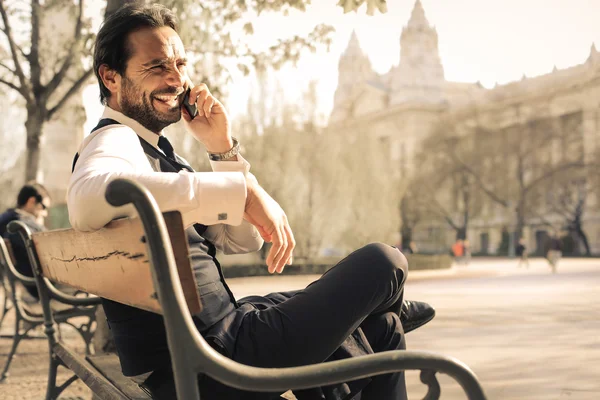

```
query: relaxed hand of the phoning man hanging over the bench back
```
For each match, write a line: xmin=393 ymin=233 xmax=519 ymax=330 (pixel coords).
xmin=244 ymin=174 xmax=296 ymax=274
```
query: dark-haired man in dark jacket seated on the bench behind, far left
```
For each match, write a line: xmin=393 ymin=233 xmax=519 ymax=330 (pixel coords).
xmin=0 ymin=183 xmax=50 ymax=299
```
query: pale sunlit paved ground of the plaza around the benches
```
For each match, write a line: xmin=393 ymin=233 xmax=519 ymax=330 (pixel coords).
xmin=0 ymin=259 xmax=600 ymax=400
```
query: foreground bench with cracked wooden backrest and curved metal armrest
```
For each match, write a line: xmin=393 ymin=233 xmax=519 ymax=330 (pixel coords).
xmin=9 ymin=179 xmax=485 ymax=400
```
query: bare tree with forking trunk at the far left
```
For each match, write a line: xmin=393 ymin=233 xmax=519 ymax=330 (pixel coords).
xmin=0 ymin=0 xmax=101 ymax=180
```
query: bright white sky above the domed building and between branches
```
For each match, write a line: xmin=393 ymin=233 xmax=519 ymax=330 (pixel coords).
xmin=84 ymin=0 xmax=600 ymax=132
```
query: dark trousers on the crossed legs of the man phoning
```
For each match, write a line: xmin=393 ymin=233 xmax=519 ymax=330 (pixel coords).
xmin=201 ymin=243 xmax=408 ymax=400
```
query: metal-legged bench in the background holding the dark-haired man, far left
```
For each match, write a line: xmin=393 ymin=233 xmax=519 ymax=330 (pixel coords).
xmin=0 ymin=239 xmax=100 ymax=382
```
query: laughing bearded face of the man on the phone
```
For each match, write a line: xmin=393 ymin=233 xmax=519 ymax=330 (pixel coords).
xmin=117 ymin=27 xmax=188 ymax=133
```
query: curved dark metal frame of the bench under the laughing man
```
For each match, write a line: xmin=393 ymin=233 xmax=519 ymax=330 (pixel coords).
xmin=9 ymin=179 xmax=486 ymax=400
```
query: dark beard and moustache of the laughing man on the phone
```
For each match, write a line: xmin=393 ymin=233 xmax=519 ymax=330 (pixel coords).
xmin=120 ymin=76 xmax=181 ymax=133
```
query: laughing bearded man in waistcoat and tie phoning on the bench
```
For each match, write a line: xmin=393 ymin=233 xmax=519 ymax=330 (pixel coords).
xmin=67 ymin=6 xmax=434 ymax=400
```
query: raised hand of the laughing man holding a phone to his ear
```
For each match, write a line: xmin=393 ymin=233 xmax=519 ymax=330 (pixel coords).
xmin=181 ymin=82 xmax=233 ymax=153
